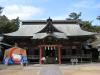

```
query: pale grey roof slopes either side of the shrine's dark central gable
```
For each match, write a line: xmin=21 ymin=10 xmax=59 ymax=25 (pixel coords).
xmin=5 ymin=21 xmax=95 ymax=39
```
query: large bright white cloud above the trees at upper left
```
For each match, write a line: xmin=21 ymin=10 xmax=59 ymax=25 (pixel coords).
xmin=3 ymin=5 xmax=43 ymax=19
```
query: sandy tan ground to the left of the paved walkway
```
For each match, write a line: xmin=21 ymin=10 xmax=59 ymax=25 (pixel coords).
xmin=0 ymin=65 xmax=41 ymax=75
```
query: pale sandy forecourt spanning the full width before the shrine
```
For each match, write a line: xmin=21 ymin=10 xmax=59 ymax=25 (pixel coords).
xmin=0 ymin=63 xmax=100 ymax=75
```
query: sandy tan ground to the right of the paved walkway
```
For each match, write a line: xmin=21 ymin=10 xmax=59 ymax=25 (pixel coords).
xmin=60 ymin=64 xmax=100 ymax=75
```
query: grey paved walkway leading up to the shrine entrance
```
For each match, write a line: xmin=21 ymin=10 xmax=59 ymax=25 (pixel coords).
xmin=39 ymin=65 xmax=62 ymax=75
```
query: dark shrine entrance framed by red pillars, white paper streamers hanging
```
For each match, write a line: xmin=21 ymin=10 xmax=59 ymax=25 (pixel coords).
xmin=39 ymin=45 xmax=61 ymax=64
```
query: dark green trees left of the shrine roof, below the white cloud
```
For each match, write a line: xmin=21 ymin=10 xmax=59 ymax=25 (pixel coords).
xmin=0 ymin=15 xmax=18 ymax=33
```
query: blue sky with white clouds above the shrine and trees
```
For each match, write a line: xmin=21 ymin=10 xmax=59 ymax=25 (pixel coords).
xmin=0 ymin=0 xmax=100 ymax=25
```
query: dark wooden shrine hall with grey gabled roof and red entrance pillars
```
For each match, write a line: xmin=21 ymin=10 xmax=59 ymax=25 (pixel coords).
xmin=4 ymin=18 xmax=95 ymax=64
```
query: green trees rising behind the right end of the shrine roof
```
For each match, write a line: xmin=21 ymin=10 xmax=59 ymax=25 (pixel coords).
xmin=69 ymin=12 xmax=100 ymax=32
